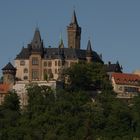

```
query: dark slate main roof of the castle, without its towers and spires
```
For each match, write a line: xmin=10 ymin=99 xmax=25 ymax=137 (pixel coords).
xmin=15 ymin=47 xmax=103 ymax=63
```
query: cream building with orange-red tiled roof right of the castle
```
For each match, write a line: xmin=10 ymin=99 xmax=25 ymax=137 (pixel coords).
xmin=111 ymin=73 xmax=140 ymax=99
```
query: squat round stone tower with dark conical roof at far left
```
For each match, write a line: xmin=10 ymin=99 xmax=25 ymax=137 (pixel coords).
xmin=2 ymin=62 xmax=16 ymax=85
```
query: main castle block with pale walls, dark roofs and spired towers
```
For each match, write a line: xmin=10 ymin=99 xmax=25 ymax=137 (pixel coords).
xmin=15 ymin=11 xmax=103 ymax=81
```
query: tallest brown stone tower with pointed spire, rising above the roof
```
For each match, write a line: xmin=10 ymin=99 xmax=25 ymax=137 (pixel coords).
xmin=67 ymin=11 xmax=81 ymax=49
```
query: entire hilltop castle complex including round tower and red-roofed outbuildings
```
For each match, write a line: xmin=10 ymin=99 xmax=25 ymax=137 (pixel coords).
xmin=0 ymin=11 xmax=140 ymax=106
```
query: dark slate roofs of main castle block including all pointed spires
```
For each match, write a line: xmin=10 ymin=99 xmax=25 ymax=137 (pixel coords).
xmin=15 ymin=24 xmax=103 ymax=63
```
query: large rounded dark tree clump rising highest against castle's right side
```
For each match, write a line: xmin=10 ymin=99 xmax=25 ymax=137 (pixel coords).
xmin=64 ymin=63 xmax=111 ymax=91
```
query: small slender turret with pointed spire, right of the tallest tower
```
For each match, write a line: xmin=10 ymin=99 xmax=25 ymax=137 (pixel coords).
xmin=86 ymin=40 xmax=93 ymax=63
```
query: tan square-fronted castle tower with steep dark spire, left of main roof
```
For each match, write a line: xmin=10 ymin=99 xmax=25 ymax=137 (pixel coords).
xmin=29 ymin=28 xmax=44 ymax=81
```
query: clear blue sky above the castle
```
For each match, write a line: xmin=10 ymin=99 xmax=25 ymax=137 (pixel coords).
xmin=0 ymin=0 xmax=140 ymax=73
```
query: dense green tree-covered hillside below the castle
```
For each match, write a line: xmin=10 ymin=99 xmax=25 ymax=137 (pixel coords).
xmin=0 ymin=64 xmax=140 ymax=140
